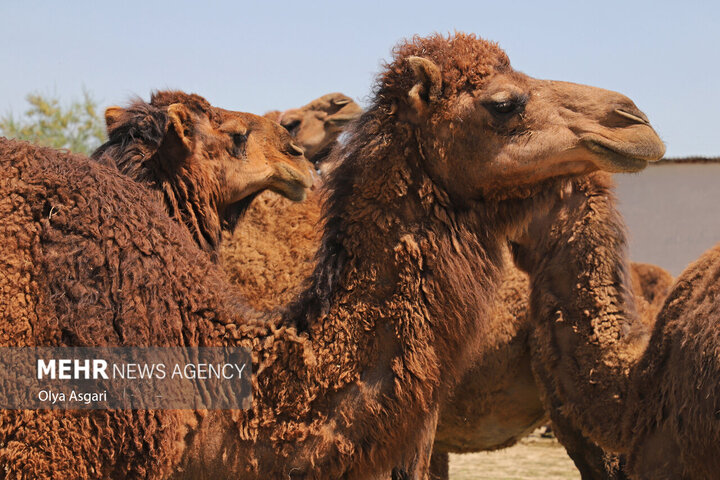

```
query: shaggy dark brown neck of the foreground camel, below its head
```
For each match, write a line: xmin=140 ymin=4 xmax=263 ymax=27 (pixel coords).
xmin=285 ymin=119 xmax=524 ymax=390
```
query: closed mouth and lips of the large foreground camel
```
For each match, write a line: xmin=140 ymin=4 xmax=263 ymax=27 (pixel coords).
xmin=583 ymin=129 xmax=665 ymax=173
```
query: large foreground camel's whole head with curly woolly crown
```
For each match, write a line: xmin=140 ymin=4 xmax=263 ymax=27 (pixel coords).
xmin=380 ymin=33 xmax=665 ymax=199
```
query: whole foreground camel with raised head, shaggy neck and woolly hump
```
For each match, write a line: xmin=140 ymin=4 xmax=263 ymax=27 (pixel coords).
xmin=0 ymin=34 xmax=664 ymax=479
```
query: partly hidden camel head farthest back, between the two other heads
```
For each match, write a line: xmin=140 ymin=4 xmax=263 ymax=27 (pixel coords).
xmin=278 ymin=93 xmax=362 ymax=164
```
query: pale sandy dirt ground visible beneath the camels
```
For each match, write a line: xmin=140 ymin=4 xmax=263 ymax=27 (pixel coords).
xmin=450 ymin=435 xmax=580 ymax=480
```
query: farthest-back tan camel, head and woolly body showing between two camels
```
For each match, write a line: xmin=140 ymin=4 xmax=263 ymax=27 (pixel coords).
xmin=220 ymin=93 xmax=362 ymax=311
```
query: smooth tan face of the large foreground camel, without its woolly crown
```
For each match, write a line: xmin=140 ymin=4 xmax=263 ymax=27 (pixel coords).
xmin=430 ymin=72 xmax=665 ymax=200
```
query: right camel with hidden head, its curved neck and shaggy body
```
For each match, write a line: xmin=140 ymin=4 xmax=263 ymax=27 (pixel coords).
xmin=515 ymin=175 xmax=720 ymax=479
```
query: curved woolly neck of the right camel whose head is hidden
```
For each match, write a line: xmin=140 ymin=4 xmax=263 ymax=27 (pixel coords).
xmin=519 ymin=176 xmax=648 ymax=451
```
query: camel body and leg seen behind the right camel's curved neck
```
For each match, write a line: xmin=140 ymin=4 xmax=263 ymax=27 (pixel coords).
xmin=432 ymin=263 xmax=673 ymax=479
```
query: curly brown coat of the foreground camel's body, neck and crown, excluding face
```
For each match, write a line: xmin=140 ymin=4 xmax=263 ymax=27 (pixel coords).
xmin=0 ymin=32 xmax=544 ymax=478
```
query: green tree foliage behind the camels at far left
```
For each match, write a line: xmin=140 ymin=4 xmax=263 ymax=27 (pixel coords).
xmin=0 ymin=90 xmax=105 ymax=155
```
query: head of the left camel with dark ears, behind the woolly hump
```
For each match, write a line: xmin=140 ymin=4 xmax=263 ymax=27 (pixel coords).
xmin=101 ymin=91 xmax=312 ymax=216
